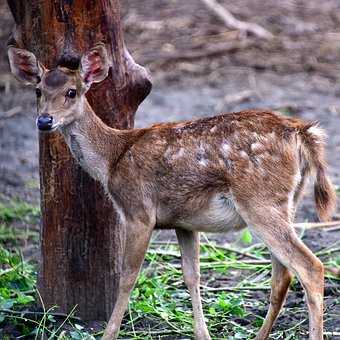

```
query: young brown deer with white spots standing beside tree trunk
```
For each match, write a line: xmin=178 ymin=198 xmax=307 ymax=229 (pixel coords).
xmin=8 ymin=44 xmax=336 ymax=340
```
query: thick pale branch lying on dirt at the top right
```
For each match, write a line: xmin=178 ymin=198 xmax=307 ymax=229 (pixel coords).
xmin=201 ymin=0 xmax=274 ymax=40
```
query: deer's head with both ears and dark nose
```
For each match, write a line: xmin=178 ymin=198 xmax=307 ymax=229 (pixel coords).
xmin=8 ymin=45 xmax=110 ymax=131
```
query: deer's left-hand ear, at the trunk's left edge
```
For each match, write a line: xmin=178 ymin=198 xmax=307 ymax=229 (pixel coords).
xmin=8 ymin=47 xmax=43 ymax=85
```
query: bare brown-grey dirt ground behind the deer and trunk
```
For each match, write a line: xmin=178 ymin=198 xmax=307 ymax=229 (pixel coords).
xmin=0 ymin=0 xmax=340 ymax=339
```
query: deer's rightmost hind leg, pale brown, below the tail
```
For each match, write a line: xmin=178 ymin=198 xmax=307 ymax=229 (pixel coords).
xmin=236 ymin=201 xmax=324 ymax=340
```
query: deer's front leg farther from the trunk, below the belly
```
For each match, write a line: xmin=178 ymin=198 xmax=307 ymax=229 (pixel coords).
xmin=176 ymin=229 xmax=211 ymax=340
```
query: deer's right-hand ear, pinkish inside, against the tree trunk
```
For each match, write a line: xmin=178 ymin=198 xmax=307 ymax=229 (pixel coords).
xmin=80 ymin=44 xmax=110 ymax=85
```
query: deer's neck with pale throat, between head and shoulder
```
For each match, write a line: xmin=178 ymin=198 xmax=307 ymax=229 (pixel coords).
xmin=62 ymin=102 xmax=126 ymax=188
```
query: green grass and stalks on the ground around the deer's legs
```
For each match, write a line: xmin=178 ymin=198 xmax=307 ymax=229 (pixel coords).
xmin=0 ymin=201 xmax=340 ymax=340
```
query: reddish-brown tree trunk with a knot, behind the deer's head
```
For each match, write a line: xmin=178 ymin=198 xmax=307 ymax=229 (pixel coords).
xmin=8 ymin=0 xmax=151 ymax=320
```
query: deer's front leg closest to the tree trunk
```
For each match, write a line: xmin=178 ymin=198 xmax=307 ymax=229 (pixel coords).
xmin=102 ymin=221 xmax=154 ymax=340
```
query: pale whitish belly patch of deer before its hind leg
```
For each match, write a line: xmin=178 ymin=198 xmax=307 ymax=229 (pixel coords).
xmin=176 ymin=194 xmax=246 ymax=233
